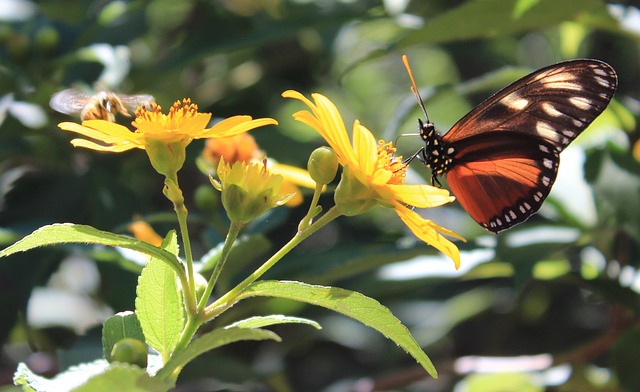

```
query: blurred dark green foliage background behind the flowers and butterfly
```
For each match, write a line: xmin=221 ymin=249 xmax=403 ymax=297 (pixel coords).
xmin=0 ymin=0 xmax=640 ymax=392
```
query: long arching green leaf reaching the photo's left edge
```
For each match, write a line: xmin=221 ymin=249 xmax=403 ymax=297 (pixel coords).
xmin=0 ymin=223 xmax=182 ymax=271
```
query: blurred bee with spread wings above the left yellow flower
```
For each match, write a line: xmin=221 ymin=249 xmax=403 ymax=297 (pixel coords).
xmin=49 ymin=88 xmax=155 ymax=122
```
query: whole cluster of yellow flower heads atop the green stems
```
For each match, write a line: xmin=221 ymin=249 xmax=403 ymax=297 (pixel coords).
xmin=59 ymin=90 xmax=462 ymax=268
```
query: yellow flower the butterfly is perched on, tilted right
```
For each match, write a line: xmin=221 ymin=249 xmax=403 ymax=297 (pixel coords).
xmin=282 ymin=90 xmax=463 ymax=268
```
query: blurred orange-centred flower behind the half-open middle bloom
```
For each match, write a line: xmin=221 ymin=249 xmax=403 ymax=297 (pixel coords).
xmin=198 ymin=133 xmax=315 ymax=207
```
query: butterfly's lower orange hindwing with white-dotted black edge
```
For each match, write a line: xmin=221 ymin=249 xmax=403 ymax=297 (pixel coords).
xmin=447 ymin=132 xmax=560 ymax=233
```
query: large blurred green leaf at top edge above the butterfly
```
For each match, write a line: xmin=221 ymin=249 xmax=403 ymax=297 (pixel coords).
xmin=398 ymin=0 xmax=617 ymax=48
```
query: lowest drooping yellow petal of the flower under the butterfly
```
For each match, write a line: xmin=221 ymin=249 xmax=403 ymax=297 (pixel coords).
xmin=395 ymin=205 xmax=462 ymax=269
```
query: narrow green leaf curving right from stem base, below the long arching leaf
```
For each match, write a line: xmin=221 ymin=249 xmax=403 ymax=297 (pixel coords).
xmin=156 ymin=327 xmax=282 ymax=379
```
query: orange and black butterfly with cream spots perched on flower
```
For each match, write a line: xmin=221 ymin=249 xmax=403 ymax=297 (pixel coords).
xmin=403 ymin=56 xmax=618 ymax=233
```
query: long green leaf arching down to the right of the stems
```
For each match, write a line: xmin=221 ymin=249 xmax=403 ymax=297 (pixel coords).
xmin=240 ymin=280 xmax=438 ymax=378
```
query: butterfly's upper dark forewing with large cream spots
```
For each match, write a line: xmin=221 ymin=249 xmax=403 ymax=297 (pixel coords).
xmin=443 ymin=60 xmax=618 ymax=152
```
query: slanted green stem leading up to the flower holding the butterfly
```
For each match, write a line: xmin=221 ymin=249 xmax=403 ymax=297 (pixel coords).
xmin=202 ymin=206 xmax=342 ymax=321
